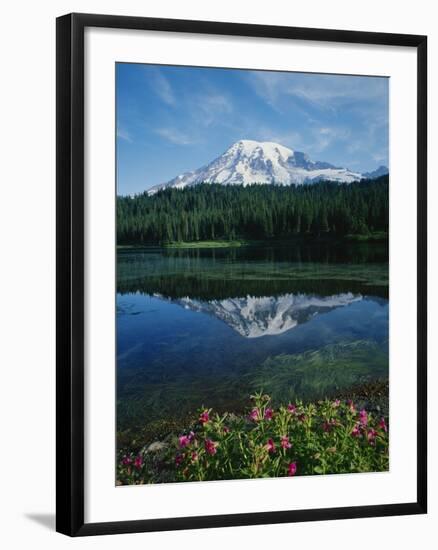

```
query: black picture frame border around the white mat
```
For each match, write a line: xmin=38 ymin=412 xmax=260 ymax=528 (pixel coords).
xmin=56 ymin=13 xmax=427 ymax=536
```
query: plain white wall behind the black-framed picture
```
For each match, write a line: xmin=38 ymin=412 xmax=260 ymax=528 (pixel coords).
xmin=0 ymin=0 xmax=438 ymax=550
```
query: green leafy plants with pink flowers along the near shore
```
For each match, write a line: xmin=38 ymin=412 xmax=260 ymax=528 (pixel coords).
xmin=118 ymin=393 xmax=389 ymax=484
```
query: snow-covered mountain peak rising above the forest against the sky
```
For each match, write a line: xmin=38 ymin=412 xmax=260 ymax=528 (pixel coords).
xmin=148 ymin=139 xmax=386 ymax=195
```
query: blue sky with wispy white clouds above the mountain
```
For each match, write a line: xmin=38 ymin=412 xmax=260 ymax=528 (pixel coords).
xmin=116 ymin=63 xmax=389 ymax=195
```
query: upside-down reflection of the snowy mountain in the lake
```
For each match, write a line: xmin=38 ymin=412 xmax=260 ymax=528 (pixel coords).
xmin=155 ymin=292 xmax=363 ymax=338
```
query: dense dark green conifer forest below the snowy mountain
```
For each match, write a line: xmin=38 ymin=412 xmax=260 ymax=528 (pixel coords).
xmin=117 ymin=175 xmax=389 ymax=244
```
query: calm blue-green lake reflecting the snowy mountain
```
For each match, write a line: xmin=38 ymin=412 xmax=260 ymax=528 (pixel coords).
xmin=117 ymin=243 xmax=389 ymax=446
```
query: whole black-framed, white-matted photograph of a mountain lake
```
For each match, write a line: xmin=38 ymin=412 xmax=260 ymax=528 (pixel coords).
xmin=57 ymin=14 xmax=427 ymax=536
